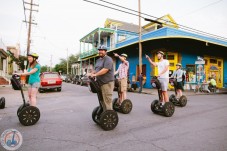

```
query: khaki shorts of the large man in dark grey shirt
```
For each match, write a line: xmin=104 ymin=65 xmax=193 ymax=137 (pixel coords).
xmin=101 ymin=81 xmax=114 ymax=111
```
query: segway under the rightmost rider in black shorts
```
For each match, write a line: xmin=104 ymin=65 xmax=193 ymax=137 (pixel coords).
xmin=169 ymin=78 xmax=187 ymax=107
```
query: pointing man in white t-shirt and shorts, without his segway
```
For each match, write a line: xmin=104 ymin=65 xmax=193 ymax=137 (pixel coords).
xmin=146 ymin=51 xmax=169 ymax=105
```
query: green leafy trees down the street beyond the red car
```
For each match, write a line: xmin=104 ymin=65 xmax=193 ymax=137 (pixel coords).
xmin=54 ymin=54 xmax=79 ymax=74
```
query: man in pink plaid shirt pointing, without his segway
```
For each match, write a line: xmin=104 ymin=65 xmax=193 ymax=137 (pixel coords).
xmin=114 ymin=53 xmax=129 ymax=105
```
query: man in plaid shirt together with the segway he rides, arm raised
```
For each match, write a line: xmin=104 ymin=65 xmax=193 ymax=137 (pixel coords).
xmin=113 ymin=53 xmax=132 ymax=114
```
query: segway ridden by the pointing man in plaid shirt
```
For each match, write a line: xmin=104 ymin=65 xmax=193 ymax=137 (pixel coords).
xmin=113 ymin=79 xmax=132 ymax=114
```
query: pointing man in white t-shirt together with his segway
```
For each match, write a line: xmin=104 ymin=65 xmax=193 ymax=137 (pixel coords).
xmin=146 ymin=51 xmax=175 ymax=117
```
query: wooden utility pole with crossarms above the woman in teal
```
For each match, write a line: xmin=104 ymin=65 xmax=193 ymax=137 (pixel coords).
xmin=23 ymin=0 xmax=39 ymax=55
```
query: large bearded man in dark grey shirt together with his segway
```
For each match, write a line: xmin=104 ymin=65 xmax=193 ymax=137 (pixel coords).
xmin=90 ymin=46 xmax=118 ymax=130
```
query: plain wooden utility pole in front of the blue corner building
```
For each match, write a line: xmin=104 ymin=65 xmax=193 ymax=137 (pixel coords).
xmin=138 ymin=0 xmax=142 ymax=74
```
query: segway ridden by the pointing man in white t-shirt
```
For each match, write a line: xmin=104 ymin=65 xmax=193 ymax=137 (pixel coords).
xmin=151 ymin=77 xmax=175 ymax=117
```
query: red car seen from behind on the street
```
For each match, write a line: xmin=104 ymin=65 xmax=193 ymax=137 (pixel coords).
xmin=39 ymin=72 xmax=62 ymax=93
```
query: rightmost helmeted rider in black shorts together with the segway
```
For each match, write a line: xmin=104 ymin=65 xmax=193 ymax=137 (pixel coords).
xmin=169 ymin=63 xmax=187 ymax=107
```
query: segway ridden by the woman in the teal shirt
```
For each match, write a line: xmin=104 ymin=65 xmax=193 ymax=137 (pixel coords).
xmin=11 ymin=74 xmax=40 ymax=126
